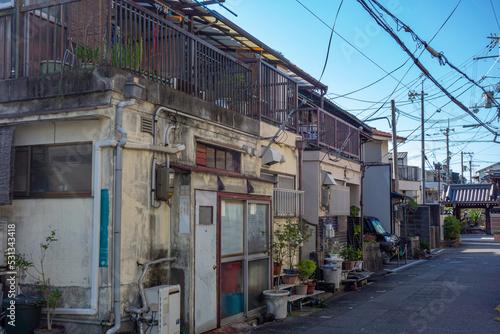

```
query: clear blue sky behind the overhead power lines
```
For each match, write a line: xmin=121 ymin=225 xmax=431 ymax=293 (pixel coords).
xmin=217 ymin=0 xmax=500 ymax=178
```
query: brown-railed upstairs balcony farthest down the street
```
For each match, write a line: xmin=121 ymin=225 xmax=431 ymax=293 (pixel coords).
xmin=298 ymin=107 xmax=360 ymax=159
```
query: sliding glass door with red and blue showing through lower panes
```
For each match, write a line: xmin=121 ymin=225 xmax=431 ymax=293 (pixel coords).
xmin=219 ymin=197 xmax=270 ymax=319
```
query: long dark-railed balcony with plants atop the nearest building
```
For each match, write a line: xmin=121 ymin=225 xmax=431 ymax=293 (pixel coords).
xmin=0 ymin=0 xmax=298 ymax=125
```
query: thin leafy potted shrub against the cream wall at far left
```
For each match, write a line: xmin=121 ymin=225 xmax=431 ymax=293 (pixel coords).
xmin=15 ymin=230 xmax=65 ymax=334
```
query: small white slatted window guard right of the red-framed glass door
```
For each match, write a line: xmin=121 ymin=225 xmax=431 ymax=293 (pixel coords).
xmin=273 ymin=188 xmax=304 ymax=217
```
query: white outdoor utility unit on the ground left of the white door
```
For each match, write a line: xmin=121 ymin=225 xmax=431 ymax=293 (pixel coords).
xmin=143 ymin=285 xmax=181 ymax=334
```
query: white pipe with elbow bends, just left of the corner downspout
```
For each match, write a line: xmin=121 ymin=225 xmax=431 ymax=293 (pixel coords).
xmin=55 ymin=140 xmax=118 ymax=321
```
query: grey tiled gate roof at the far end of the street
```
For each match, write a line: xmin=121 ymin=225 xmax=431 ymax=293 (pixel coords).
xmin=443 ymin=184 xmax=500 ymax=205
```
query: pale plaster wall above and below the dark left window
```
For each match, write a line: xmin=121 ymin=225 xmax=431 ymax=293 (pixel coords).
xmin=0 ymin=119 xmax=109 ymax=288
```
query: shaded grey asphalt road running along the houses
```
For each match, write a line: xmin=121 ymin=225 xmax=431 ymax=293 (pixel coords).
xmin=252 ymin=235 xmax=500 ymax=334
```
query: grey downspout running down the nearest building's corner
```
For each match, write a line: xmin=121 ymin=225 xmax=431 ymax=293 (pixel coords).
xmin=106 ymin=99 xmax=135 ymax=334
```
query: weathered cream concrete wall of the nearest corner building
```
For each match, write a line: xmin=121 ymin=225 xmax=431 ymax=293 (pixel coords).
xmin=0 ymin=68 xmax=268 ymax=333
